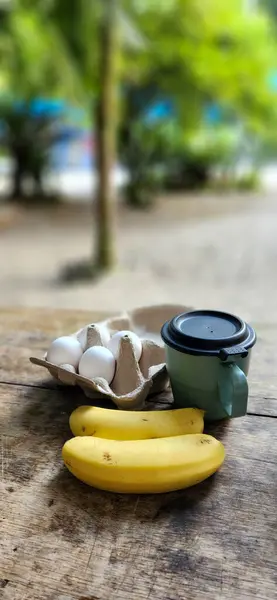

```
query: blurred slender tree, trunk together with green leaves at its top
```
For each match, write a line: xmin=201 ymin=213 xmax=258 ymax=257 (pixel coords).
xmin=42 ymin=0 xmax=142 ymax=271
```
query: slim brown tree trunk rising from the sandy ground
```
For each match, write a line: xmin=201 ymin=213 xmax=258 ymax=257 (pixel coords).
xmin=95 ymin=0 xmax=118 ymax=270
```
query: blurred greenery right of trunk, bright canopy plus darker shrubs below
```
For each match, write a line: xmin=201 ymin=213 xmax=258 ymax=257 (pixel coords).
xmin=120 ymin=0 xmax=277 ymax=205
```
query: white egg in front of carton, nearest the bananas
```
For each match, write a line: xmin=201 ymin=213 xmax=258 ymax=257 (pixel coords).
xmin=79 ymin=346 xmax=115 ymax=383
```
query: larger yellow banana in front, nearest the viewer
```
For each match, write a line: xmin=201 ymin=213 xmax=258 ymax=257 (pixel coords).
xmin=62 ymin=434 xmax=225 ymax=494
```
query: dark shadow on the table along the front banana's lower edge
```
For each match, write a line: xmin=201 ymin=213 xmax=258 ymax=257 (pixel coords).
xmin=48 ymin=454 xmax=221 ymax=536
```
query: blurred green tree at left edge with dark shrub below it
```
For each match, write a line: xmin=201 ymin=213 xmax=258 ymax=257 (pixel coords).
xmin=0 ymin=0 xmax=82 ymax=200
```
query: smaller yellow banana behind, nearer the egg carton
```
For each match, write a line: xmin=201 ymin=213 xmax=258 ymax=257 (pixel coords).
xmin=69 ymin=406 xmax=204 ymax=440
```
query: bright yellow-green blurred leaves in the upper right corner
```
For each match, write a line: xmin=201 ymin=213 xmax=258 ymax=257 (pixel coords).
xmin=126 ymin=0 xmax=277 ymax=130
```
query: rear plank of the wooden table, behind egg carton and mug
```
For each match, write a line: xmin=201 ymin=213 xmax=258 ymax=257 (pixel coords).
xmin=0 ymin=308 xmax=277 ymax=416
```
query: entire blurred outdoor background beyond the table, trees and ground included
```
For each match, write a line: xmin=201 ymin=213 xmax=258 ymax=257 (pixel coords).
xmin=0 ymin=0 xmax=277 ymax=322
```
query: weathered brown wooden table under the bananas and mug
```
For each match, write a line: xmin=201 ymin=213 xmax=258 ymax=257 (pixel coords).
xmin=0 ymin=309 xmax=277 ymax=600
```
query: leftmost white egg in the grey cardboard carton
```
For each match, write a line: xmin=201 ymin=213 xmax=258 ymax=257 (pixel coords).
xmin=47 ymin=335 xmax=83 ymax=369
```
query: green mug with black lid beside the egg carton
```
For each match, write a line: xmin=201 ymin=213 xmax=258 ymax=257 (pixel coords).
xmin=161 ymin=310 xmax=256 ymax=421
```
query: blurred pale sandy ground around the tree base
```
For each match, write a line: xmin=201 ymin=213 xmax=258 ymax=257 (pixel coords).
xmin=0 ymin=194 xmax=277 ymax=322
